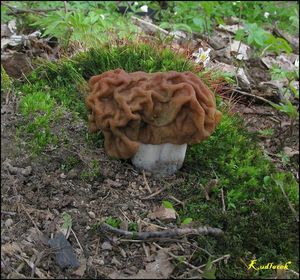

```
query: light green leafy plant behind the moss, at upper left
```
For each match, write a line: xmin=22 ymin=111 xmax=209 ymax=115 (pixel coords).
xmin=32 ymin=6 xmax=137 ymax=48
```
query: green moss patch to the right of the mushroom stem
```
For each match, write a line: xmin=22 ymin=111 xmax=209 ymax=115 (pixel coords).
xmin=176 ymin=112 xmax=299 ymax=278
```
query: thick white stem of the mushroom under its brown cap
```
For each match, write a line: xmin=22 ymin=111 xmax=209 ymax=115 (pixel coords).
xmin=131 ymin=143 xmax=187 ymax=176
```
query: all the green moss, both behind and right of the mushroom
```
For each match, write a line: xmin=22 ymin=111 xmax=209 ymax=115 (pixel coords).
xmin=14 ymin=41 xmax=299 ymax=278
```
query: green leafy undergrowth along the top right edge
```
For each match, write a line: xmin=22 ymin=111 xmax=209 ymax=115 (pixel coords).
xmin=156 ymin=1 xmax=299 ymax=40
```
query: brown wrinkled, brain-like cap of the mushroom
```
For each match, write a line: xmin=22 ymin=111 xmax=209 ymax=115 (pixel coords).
xmin=86 ymin=69 xmax=221 ymax=159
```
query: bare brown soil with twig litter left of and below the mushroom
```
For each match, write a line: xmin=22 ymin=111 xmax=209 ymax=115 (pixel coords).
xmin=1 ymin=91 xmax=202 ymax=278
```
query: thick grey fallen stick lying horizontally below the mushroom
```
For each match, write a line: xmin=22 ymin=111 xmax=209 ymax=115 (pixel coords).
xmin=99 ymin=223 xmax=223 ymax=240
